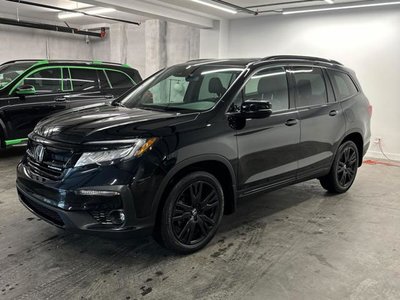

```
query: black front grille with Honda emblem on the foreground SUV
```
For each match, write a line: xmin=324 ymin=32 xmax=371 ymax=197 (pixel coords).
xmin=27 ymin=140 xmax=74 ymax=181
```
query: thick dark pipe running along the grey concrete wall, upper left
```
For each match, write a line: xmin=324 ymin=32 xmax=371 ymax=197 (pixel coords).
xmin=0 ymin=18 xmax=104 ymax=38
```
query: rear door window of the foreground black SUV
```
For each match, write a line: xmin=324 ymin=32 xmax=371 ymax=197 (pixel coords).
xmin=290 ymin=67 xmax=328 ymax=107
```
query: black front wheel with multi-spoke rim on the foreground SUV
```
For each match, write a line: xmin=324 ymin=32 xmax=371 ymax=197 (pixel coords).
xmin=158 ymin=171 xmax=224 ymax=254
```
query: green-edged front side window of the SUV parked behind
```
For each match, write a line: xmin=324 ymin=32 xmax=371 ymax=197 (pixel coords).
xmin=22 ymin=68 xmax=61 ymax=93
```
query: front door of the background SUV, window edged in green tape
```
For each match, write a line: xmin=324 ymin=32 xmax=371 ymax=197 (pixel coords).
xmin=3 ymin=67 xmax=67 ymax=139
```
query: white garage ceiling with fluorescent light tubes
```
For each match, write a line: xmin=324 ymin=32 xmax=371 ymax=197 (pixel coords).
xmin=0 ymin=0 xmax=384 ymax=28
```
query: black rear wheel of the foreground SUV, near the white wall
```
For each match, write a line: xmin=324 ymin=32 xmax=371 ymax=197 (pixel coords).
xmin=319 ymin=141 xmax=359 ymax=194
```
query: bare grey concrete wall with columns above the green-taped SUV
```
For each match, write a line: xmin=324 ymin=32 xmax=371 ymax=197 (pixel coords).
xmin=0 ymin=20 xmax=200 ymax=77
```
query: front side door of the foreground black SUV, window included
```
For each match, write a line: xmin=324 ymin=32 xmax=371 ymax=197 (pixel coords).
xmin=235 ymin=67 xmax=300 ymax=194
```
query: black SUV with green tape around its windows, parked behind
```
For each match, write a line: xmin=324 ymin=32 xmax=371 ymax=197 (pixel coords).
xmin=0 ymin=60 xmax=141 ymax=149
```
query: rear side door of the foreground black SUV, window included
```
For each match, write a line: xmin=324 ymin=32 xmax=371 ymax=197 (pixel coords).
xmin=289 ymin=66 xmax=345 ymax=178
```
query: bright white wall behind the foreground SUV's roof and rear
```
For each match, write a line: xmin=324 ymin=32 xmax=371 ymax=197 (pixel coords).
xmin=200 ymin=7 xmax=400 ymax=160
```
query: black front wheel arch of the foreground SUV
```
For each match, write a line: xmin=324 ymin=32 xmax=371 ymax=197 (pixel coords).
xmin=153 ymin=155 xmax=237 ymax=222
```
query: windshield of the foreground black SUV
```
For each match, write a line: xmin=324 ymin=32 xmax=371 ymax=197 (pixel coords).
xmin=120 ymin=65 xmax=243 ymax=112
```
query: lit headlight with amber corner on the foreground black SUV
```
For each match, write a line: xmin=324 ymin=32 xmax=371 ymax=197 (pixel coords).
xmin=75 ymin=138 xmax=157 ymax=167
